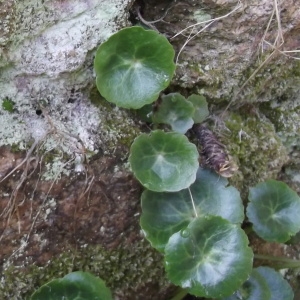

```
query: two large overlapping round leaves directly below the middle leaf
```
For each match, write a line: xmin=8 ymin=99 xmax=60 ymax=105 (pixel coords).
xmin=141 ymin=169 xmax=253 ymax=298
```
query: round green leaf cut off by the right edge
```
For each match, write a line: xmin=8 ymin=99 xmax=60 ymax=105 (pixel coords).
xmin=247 ymin=180 xmax=300 ymax=243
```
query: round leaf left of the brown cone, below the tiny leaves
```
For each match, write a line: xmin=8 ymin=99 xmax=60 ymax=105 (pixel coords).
xmin=129 ymin=130 xmax=199 ymax=192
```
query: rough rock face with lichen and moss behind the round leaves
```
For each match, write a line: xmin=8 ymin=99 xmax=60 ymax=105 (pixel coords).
xmin=0 ymin=0 xmax=300 ymax=300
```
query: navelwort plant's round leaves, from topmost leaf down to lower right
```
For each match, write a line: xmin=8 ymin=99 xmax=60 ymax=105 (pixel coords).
xmin=32 ymin=27 xmax=300 ymax=300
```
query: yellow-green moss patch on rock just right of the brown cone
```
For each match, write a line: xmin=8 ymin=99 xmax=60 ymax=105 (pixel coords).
xmin=224 ymin=113 xmax=288 ymax=193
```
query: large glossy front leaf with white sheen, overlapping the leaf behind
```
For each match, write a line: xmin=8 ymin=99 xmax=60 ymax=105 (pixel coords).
xmin=165 ymin=216 xmax=253 ymax=298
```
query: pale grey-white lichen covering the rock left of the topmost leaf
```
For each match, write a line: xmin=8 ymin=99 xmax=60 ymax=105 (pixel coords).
xmin=0 ymin=0 xmax=134 ymax=169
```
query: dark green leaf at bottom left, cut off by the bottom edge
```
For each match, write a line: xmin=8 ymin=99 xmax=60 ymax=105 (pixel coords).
xmin=30 ymin=271 xmax=112 ymax=300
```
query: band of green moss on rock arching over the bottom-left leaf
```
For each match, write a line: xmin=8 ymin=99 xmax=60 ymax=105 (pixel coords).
xmin=0 ymin=240 xmax=169 ymax=300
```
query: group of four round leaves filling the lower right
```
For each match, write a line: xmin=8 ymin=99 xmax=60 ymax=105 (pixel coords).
xmin=140 ymin=169 xmax=300 ymax=300
